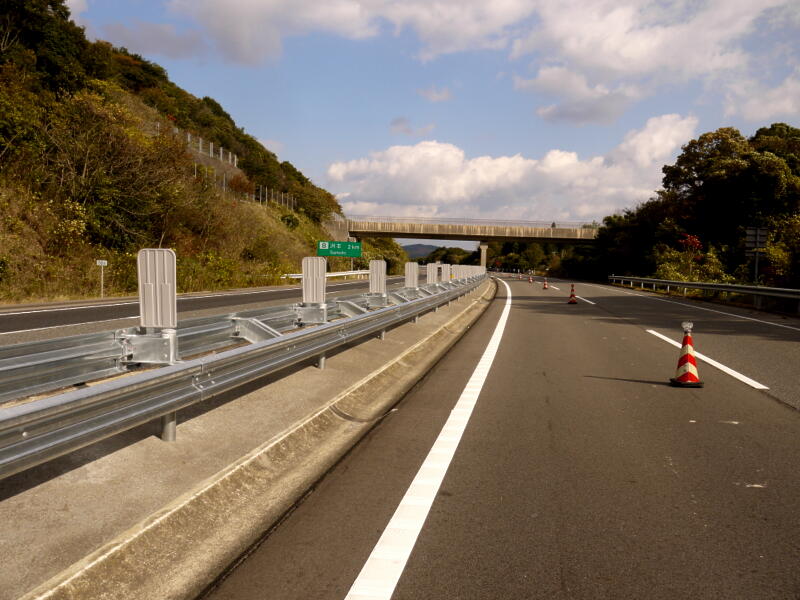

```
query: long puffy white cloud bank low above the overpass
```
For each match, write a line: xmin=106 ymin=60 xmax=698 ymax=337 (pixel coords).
xmin=328 ymin=115 xmax=697 ymax=220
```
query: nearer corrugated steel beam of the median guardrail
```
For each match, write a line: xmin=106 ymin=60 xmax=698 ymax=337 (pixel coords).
xmin=0 ymin=268 xmax=485 ymax=477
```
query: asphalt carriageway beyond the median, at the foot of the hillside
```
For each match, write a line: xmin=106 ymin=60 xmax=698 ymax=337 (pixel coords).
xmin=0 ymin=277 xmax=402 ymax=338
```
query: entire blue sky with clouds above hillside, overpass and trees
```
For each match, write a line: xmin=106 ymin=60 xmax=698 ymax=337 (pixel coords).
xmin=68 ymin=0 xmax=800 ymax=231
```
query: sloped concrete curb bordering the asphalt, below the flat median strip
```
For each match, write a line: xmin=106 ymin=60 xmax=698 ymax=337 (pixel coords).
xmin=22 ymin=281 xmax=497 ymax=600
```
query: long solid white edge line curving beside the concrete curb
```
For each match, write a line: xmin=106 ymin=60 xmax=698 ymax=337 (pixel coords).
xmin=346 ymin=279 xmax=511 ymax=600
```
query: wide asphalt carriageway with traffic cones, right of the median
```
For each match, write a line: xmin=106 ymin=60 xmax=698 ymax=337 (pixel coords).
xmin=206 ymin=281 xmax=800 ymax=600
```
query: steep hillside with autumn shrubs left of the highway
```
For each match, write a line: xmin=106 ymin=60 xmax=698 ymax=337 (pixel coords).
xmin=0 ymin=0 xmax=406 ymax=301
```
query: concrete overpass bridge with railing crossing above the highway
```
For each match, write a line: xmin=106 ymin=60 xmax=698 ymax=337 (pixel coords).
xmin=344 ymin=215 xmax=599 ymax=266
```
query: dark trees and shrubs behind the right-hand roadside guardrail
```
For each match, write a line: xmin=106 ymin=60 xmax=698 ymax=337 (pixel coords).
xmin=454 ymin=123 xmax=800 ymax=288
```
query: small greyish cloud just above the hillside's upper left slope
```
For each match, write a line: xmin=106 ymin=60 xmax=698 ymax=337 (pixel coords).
xmin=102 ymin=21 xmax=207 ymax=58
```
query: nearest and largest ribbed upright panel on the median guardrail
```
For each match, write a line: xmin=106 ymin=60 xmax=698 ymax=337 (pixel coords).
xmin=136 ymin=248 xmax=178 ymax=329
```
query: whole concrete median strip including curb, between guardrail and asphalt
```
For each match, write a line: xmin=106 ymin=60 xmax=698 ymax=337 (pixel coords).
xmin=0 ymin=281 xmax=496 ymax=600
